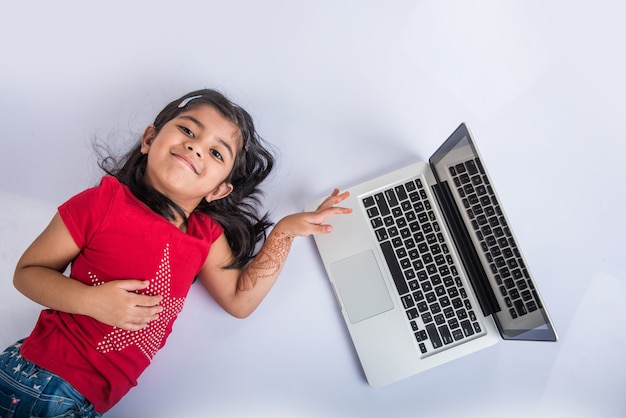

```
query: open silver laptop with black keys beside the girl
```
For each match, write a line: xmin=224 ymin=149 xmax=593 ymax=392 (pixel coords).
xmin=306 ymin=124 xmax=557 ymax=387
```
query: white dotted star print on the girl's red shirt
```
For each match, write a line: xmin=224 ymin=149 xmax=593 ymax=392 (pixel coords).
xmin=90 ymin=244 xmax=185 ymax=361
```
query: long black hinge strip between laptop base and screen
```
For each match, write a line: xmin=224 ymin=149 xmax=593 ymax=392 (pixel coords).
xmin=432 ymin=181 xmax=500 ymax=316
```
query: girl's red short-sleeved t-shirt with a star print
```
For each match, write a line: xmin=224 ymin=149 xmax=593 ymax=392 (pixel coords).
xmin=21 ymin=176 xmax=223 ymax=413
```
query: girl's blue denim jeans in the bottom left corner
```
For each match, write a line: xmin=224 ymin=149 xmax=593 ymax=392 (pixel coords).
xmin=0 ymin=341 xmax=101 ymax=418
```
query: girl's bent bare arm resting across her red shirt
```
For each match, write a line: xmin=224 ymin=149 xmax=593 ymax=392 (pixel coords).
xmin=13 ymin=213 xmax=162 ymax=330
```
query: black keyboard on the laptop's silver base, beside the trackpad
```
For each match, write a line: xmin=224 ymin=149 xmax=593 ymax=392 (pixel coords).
xmin=362 ymin=178 xmax=482 ymax=354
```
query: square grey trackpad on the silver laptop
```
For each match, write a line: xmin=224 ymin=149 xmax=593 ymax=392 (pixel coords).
xmin=331 ymin=250 xmax=393 ymax=324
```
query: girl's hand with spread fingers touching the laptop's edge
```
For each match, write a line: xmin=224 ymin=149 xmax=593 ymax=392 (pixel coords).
xmin=274 ymin=189 xmax=352 ymax=236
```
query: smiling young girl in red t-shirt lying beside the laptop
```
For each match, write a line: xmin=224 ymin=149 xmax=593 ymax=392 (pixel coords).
xmin=0 ymin=90 xmax=349 ymax=417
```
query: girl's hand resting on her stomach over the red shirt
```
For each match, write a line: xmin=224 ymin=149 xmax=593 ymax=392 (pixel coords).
xmin=89 ymin=280 xmax=163 ymax=331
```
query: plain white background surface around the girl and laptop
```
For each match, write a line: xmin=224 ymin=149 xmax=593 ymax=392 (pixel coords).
xmin=0 ymin=0 xmax=626 ymax=418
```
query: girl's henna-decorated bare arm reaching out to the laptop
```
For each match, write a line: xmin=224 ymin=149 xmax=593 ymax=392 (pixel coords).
xmin=199 ymin=190 xmax=351 ymax=318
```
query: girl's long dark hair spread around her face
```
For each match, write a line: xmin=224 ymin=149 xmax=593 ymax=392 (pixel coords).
xmin=98 ymin=89 xmax=274 ymax=268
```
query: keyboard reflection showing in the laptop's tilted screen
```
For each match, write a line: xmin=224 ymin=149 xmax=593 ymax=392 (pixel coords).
xmin=450 ymin=158 xmax=542 ymax=319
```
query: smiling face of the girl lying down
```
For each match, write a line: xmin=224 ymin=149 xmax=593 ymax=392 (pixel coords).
xmin=141 ymin=105 xmax=241 ymax=214
